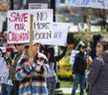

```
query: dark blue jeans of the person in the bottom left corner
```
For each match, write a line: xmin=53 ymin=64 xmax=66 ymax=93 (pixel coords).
xmin=1 ymin=84 xmax=12 ymax=95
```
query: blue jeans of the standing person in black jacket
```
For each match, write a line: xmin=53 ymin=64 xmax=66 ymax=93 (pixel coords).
xmin=72 ymin=74 xmax=85 ymax=95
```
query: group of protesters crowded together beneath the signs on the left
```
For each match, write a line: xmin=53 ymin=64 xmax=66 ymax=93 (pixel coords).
xmin=0 ymin=44 xmax=66 ymax=95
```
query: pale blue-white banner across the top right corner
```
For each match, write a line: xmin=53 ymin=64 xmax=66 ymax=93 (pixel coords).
xmin=67 ymin=0 xmax=108 ymax=9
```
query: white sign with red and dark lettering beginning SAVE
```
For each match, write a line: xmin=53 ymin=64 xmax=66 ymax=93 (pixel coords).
xmin=7 ymin=10 xmax=30 ymax=43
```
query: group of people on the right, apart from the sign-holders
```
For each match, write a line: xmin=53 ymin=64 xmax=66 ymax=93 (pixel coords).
xmin=71 ymin=38 xmax=108 ymax=95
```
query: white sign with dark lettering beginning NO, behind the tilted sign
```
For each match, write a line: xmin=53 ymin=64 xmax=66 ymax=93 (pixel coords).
xmin=32 ymin=9 xmax=53 ymax=35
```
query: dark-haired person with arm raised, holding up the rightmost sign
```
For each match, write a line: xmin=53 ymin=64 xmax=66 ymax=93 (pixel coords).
xmin=47 ymin=47 xmax=66 ymax=95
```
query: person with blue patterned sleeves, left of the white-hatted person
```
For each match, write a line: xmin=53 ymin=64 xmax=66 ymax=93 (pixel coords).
xmin=16 ymin=58 xmax=33 ymax=95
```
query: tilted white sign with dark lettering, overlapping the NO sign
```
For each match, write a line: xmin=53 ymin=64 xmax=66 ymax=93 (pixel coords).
xmin=34 ymin=23 xmax=69 ymax=46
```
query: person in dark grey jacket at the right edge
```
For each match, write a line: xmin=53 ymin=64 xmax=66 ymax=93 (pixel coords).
xmin=88 ymin=41 xmax=108 ymax=95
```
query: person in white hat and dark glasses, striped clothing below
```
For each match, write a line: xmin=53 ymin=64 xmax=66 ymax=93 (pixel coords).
xmin=32 ymin=52 xmax=48 ymax=95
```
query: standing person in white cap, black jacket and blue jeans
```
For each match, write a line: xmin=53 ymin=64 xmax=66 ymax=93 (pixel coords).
xmin=71 ymin=44 xmax=87 ymax=95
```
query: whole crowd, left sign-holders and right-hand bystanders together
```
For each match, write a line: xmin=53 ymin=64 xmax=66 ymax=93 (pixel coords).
xmin=0 ymin=36 xmax=108 ymax=95
